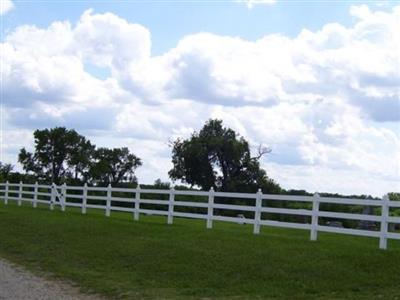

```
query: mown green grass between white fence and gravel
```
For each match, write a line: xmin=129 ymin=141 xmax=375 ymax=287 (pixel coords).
xmin=0 ymin=202 xmax=400 ymax=299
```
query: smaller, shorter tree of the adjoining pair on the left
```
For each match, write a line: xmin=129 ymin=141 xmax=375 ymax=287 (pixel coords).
xmin=89 ymin=147 xmax=142 ymax=185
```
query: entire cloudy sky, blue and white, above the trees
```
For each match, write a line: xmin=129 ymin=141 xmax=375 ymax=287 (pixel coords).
xmin=0 ymin=0 xmax=400 ymax=196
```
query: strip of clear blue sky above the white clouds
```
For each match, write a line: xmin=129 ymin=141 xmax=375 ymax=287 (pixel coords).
xmin=4 ymin=0 xmax=390 ymax=54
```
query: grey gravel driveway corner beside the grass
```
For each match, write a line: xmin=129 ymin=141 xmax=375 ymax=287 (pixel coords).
xmin=0 ymin=258 xmax=101 ymax=300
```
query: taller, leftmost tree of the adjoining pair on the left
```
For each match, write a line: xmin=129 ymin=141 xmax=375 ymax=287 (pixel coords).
xmin=18 ymin=127 xmax=94 ymax=184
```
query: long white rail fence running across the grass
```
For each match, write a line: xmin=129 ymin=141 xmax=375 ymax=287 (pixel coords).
xmin=0 ymin=182 xmax=400 ymax=249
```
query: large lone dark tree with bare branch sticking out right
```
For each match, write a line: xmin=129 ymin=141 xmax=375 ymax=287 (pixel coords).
xmin=169 ymin=120 xmax=280 ymax=193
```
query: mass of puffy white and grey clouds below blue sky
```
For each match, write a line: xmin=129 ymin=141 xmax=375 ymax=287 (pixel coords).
xmin=1 ymin=5 xmax=400 ymax=194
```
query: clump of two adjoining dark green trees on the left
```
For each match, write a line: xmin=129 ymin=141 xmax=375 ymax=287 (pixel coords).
xmin=18 ymin=127 xmax=142 ymax=184
